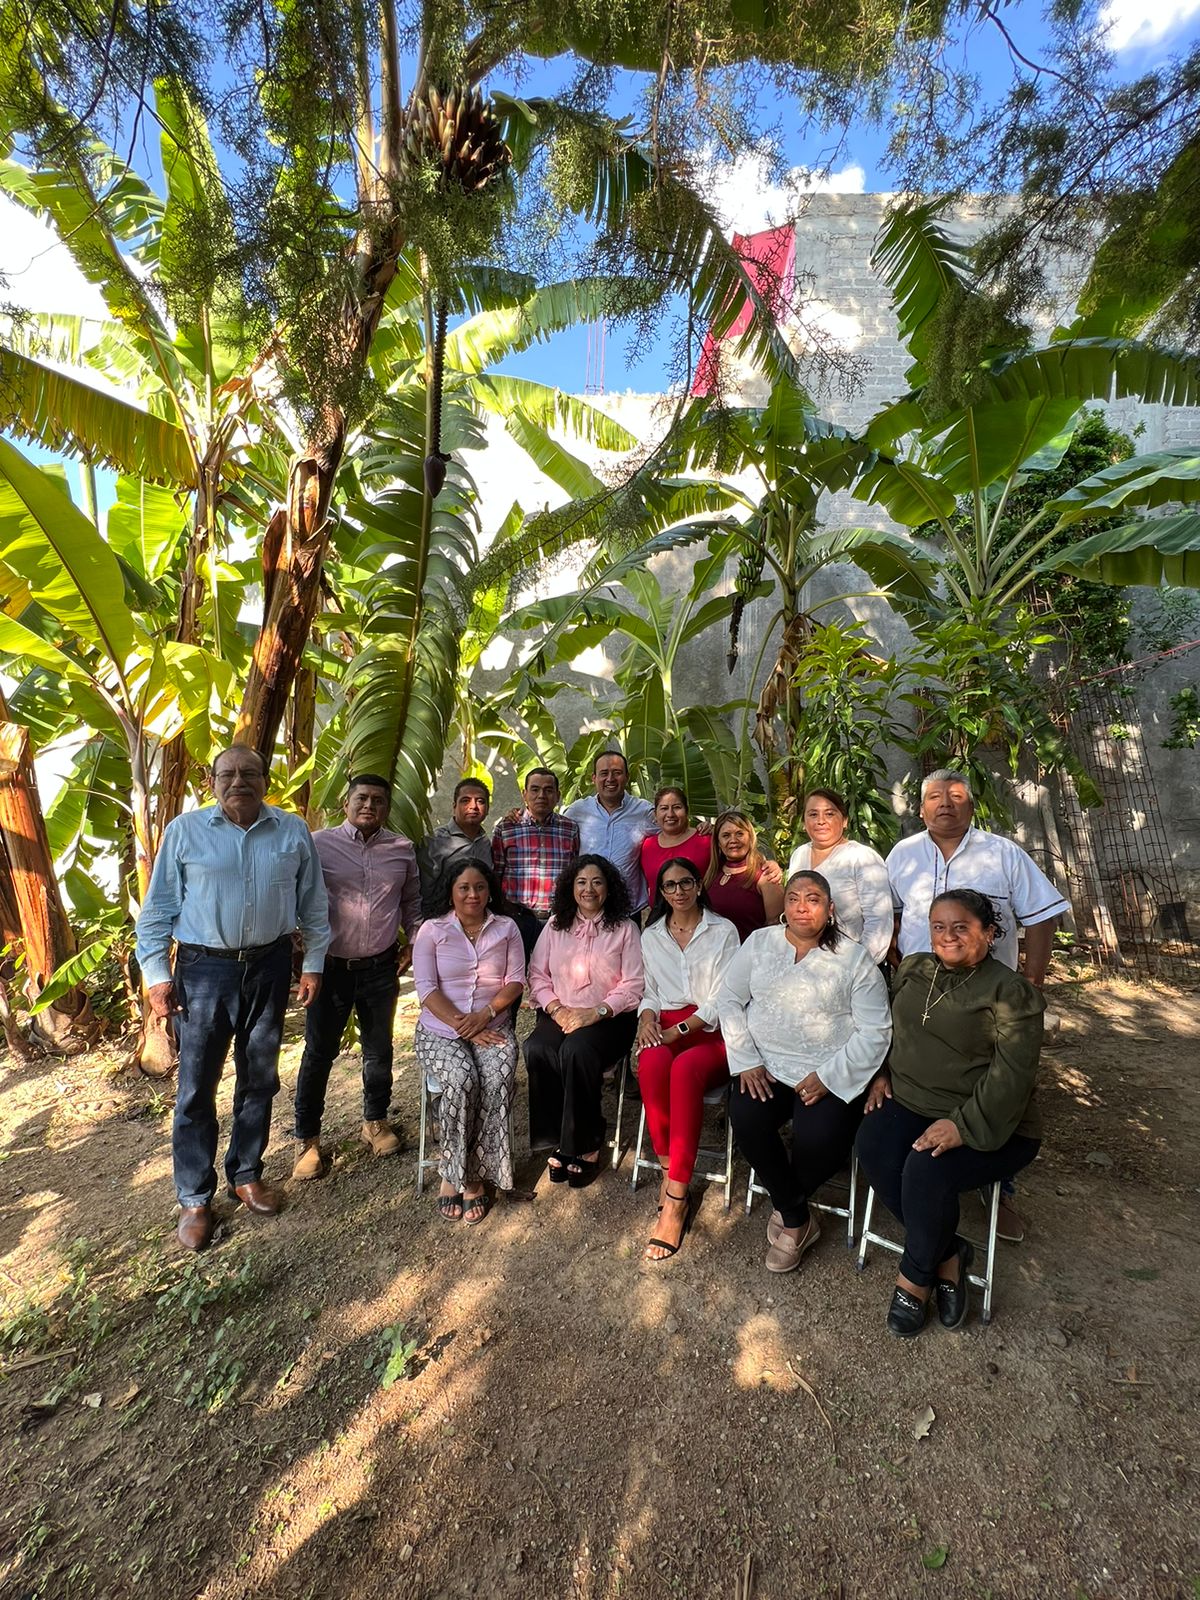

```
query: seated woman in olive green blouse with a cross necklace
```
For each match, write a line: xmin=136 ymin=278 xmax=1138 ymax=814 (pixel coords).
xmin=858 ymin=890 xmax=1045 ymax=1339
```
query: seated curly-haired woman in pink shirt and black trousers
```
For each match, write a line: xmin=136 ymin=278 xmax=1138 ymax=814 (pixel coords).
xmin=525 ymin=856 xmax=643 ymax=1189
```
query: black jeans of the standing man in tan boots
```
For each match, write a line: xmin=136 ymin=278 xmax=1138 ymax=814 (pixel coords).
xmin=296 ymin=954 xmax=400 ymax=1139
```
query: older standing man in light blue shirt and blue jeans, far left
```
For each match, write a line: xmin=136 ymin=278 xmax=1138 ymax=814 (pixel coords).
xmin=138 ymin=746 xmax=330 ymax=1250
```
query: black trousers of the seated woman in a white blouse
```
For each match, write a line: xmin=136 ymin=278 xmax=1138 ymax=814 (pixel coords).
xmin=730 ymin=1077 xmax=866 ymax=1227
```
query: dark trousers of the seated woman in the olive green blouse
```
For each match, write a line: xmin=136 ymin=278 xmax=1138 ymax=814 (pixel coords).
xmin=856 ymin=1099 xmax=1038 ymax=1286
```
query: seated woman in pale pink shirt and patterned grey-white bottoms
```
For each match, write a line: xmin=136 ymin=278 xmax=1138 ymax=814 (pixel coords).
xmin=413 ymin=861 xmax=525 ymax=1222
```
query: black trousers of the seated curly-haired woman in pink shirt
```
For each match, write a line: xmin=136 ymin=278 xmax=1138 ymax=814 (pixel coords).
xmin=525 ymin=1008 xmax=637 ymax=1155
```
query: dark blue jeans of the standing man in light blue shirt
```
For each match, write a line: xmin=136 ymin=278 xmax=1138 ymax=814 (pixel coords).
xmin=171 ymin=939 xmax=291 ymax=1206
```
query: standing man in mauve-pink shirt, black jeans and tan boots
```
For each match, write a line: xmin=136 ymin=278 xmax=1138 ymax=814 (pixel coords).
xmin=291 ymin=773 xmax=421 ymax=1178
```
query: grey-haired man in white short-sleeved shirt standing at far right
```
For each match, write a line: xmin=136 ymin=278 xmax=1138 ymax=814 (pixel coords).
xmin=888 ymin=768 xmax=1070 ymax=1240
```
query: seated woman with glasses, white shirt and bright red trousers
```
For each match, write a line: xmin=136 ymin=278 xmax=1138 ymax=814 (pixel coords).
xmin=637 ymin=856 xmax=739 ymax=1261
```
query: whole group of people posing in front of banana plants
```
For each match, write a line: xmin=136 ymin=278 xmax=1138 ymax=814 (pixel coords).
xmin=138 ymin=747 xmax=1069 ymax=1336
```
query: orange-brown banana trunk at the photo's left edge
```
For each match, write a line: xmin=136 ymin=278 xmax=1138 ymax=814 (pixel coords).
xmin=0 ymin=722 xmax=96 ymax=1056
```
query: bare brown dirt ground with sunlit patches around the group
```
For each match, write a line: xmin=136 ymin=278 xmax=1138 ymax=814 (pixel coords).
xmin=0 ymin=981 xmax=1200 ymax=1600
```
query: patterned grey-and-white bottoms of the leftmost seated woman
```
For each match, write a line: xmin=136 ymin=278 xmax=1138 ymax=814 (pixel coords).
xmin=414 ymin=1022 xmax=517 ymax=1190
